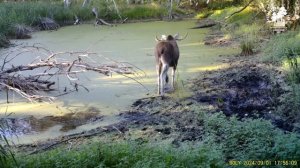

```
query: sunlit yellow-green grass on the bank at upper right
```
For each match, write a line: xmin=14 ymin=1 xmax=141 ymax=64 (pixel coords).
xmin=196 ymin=6 xmax=266 ymax=55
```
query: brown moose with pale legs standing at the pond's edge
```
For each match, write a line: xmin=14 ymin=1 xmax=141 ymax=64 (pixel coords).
xmin=154 ymin=33 xmax=188 ymax=96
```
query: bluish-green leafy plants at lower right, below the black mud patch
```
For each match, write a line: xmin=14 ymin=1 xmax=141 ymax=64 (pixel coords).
xmin=204 ymin=113 xmax=300 ymax=161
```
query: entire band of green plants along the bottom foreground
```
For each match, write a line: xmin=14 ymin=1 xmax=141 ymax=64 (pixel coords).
xmin=4 ymin=113 xmax=300 ymax=168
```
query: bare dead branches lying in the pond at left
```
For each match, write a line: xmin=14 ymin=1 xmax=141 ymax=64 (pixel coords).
xmin=0 ymin=46 xmax=140 ymax=102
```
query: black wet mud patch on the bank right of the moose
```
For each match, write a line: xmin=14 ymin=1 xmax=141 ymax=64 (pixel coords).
xmin=191 ymin=56 xmax=293 ymax=131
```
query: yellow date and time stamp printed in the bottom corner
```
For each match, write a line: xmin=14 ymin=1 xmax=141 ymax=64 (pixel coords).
xmin=228 ymin=160 xmax=299 ymax=167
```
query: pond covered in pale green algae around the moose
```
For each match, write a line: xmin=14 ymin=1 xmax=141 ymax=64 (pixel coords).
xmin=0 ymin=20 xmax=239 ymax=143
